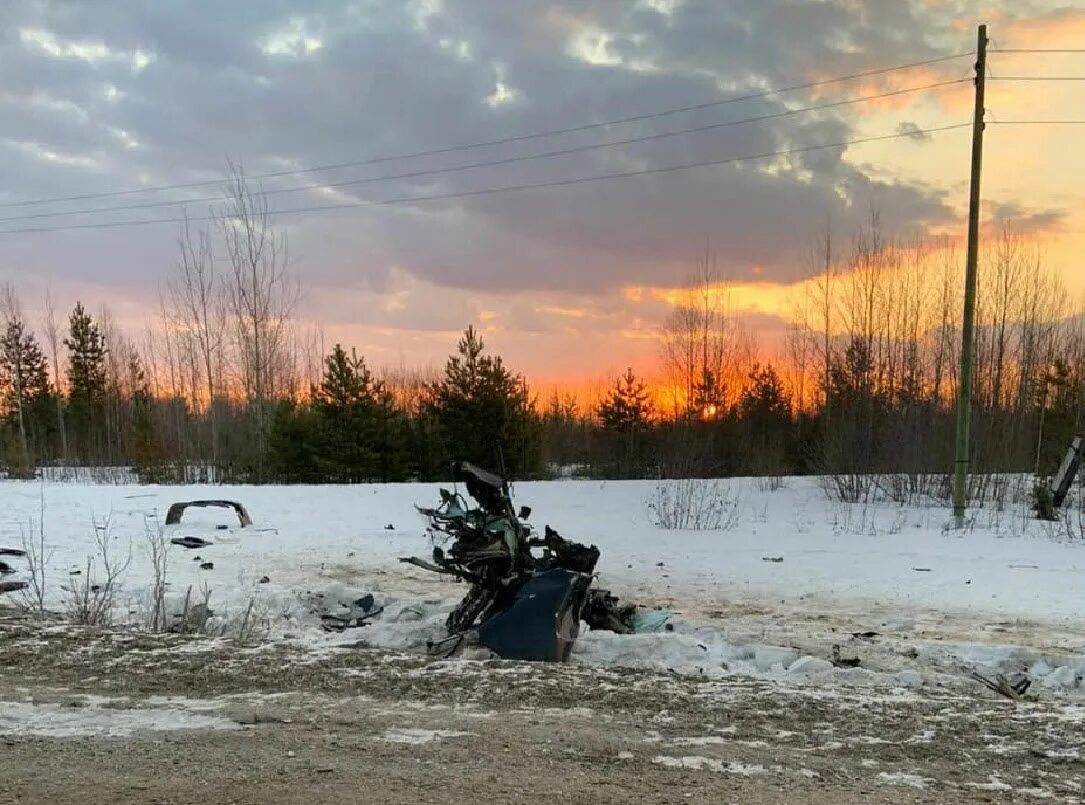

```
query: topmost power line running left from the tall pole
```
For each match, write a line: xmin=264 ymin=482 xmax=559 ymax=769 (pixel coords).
xmin=0 ymin=52 xmax=972 ymax=207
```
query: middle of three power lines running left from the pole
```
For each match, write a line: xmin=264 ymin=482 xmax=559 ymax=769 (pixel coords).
xmin=0 ymin=78 xmax=972 ymax=223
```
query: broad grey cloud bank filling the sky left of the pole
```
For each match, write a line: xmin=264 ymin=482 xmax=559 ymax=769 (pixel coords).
xmin=0 ymin=0 xmax=1058 ymax=319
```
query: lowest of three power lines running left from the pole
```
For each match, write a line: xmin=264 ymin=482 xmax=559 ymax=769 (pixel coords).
xmin=0 ymin=123 xmax=971 ymax=235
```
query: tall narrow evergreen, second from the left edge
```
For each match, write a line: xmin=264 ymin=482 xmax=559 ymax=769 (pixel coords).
xmin=64 ymin=303 xmax=106 ymax=460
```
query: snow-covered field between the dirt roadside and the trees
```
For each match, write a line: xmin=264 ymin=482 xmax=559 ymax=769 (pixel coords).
xmin=0 ymin=478 xmax=1085 ymax=690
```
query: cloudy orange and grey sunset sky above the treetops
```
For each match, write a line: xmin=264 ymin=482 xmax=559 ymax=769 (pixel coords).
xmin=0 ymin=0 xmax=1085 ymax=383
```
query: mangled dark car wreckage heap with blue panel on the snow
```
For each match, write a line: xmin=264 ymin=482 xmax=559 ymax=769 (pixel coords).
xmin=400 ymin=462 xmax=668 ymax=662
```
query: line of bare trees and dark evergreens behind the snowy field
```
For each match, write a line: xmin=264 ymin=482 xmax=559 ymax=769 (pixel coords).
xmin=0 ymin=167 xmax=1085 ymax=500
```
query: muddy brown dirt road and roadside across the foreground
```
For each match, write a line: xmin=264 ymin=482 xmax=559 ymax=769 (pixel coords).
xmin=0 ymin=622 xmax=1085 ymax=805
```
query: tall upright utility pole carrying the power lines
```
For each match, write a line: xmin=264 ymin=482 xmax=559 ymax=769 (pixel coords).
xmin=953 ymin=25 xmax=987 ymax=528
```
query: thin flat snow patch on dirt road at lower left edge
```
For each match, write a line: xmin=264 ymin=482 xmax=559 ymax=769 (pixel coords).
xmin=0 ymin=702 xmax=241 ymax=738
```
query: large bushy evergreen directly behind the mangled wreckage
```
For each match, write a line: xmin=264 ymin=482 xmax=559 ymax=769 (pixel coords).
xmin=426 ymin=327 xmax=540 ymax=476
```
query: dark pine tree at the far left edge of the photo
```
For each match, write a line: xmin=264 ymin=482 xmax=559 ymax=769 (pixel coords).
xmin=0 ymin=317 xmax=50 ymax=475
